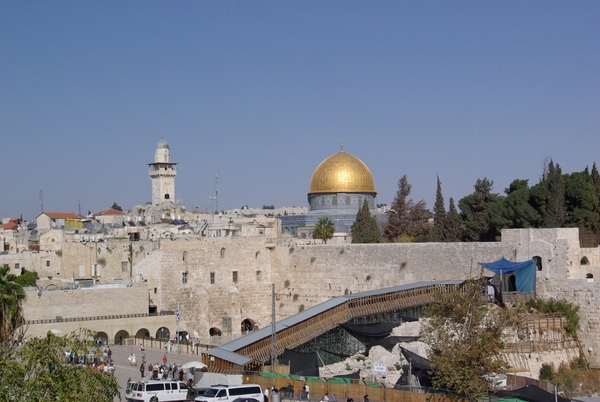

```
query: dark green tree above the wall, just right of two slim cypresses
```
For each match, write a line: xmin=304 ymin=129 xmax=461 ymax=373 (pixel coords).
xmin=458 ymin=178 xmax=502 ymax=241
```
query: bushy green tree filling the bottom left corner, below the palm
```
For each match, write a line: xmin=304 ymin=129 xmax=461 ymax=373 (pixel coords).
xmin=0 ymin=330 xmax=120 ymax=402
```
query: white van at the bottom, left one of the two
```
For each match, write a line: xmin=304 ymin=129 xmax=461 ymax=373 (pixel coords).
xmin=125 ymin=380 xmax=188 ymax=402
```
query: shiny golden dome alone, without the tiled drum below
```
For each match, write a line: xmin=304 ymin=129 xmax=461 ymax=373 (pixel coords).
xmin=308 ymin=151 xmax=376 ymax=194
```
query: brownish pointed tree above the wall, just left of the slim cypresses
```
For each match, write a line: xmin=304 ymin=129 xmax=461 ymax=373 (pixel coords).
xmin=383 ymin=175 xmax=431 ymax=242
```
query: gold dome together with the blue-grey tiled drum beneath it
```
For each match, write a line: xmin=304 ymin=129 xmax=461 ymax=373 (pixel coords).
xmin=308 ymin=151 xmax=377 ymax=211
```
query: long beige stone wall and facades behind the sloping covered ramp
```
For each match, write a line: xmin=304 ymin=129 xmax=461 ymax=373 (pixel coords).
xmin=7 ymin=222 xmax=600 ymax=366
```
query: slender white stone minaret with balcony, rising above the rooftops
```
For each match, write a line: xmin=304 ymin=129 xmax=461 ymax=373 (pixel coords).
xmin=148 ymin=139 xmax=177 ymax=205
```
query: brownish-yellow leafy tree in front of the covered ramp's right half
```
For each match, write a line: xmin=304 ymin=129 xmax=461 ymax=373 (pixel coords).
xmin=421 ymin=280 xmax=511 ymax=398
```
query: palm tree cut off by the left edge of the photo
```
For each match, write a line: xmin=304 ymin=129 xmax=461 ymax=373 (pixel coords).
xmin=0 ymin=266 xmax=27 ymax=343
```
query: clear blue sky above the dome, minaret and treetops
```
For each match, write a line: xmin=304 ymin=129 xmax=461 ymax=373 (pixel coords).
xmin=0 ymin=1 xmax=600 ymax=219
